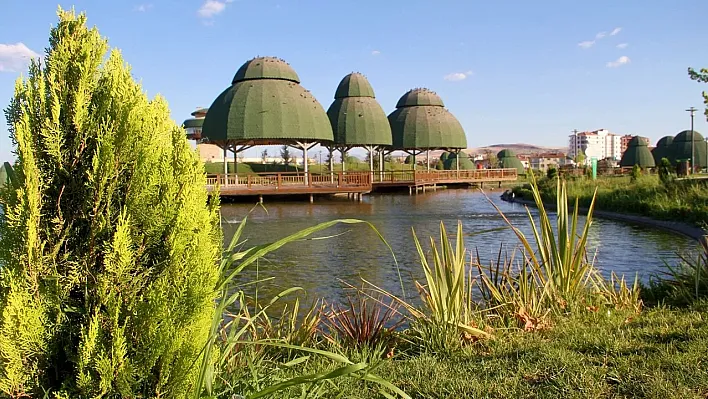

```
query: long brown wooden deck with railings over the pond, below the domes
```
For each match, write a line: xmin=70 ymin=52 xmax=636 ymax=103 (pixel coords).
xmin=207 ymin=169 xmax=517 ymax=198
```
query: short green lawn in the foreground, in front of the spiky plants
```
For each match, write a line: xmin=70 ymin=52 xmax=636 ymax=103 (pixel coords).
xmin=271 ymin=302 xmax=708 ymax=399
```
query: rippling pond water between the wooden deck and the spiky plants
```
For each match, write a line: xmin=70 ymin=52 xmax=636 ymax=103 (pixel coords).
xmin=222 ymin=189 xmax=695 ymax=301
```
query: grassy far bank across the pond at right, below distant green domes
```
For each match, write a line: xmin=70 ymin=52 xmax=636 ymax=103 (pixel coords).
xmin=513 ymin=175 xmax=708 ymax=227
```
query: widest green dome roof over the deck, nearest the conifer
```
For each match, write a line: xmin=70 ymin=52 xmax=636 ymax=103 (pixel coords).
xmin=202 ymin=58 xmax=334 ymax=145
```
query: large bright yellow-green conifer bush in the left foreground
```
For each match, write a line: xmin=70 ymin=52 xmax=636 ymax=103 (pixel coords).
xmin=0 ymin=9 xmax=221 ymax=398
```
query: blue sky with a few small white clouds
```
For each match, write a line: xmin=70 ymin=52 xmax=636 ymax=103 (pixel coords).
xmin=0 ymin=0 xmax=708 ymax=160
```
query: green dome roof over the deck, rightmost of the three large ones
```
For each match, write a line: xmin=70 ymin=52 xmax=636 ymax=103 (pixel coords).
xmin=388 ymin=89 xmax=467 ymax=150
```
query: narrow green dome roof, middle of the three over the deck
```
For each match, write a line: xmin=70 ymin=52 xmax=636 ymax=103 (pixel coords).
xmin=327 ymin=73 xmax=391 ymax=147
